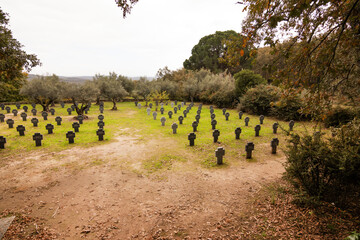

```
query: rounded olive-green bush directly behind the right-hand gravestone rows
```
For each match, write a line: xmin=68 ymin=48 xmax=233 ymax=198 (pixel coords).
xmin=239 ymin=85 xmax=280 ymax=115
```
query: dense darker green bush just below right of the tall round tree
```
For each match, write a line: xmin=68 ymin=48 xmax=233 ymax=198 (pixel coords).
xmin=234 ymin=69 xmax=267 ymax=97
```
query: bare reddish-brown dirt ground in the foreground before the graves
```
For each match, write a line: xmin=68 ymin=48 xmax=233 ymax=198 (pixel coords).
xmin=0 ymin=129 xmax=285 ymax=239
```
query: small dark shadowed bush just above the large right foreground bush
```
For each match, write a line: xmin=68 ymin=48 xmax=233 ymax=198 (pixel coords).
xmin=324 ymin=107 xmax=356 ymax=128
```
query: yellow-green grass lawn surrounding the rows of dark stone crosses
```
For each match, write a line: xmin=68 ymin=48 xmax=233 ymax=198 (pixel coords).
xmin=0 ymin=102 xmax=318 ymax=172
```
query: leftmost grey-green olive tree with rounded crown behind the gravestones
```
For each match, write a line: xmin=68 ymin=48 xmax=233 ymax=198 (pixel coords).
xmin=20 ymin=75 xmax=61 ymax=111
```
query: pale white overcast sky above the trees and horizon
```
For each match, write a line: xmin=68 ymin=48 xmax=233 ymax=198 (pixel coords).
xmin=0 ymin=0 xmax=246 ymax=77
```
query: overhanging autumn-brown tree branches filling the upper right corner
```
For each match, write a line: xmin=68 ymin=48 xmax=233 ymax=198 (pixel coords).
xmin=242 ymin=0 xmax=360 ymax=118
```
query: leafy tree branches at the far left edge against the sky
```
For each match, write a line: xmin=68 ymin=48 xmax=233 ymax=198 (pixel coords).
xmin=0 ymin=8 xmax=40 ymax=101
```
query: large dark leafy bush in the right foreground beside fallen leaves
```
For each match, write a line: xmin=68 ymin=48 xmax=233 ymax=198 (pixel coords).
xmin=285 ymin=120 xmax=360 ymax=206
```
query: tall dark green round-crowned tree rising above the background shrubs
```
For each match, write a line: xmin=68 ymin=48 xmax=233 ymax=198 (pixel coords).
xmin=183 ymin=30 xmax=250 ymax=73
